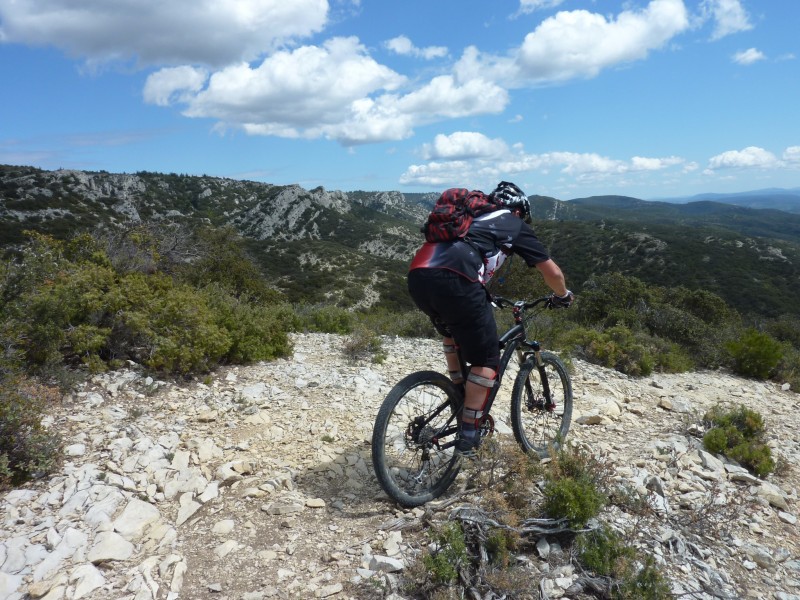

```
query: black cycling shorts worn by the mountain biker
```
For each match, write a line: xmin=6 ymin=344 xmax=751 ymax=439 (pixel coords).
xmin=408 ymin=269 xmax=500 ymax=369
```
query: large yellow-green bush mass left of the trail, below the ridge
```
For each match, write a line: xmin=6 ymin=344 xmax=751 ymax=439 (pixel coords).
xmin=0 ymin=232 xmax=296 ymax=374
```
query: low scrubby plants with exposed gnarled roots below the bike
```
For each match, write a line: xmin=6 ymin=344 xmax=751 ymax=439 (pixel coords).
xmin=405 ymin=438 xmax=669 ymax=600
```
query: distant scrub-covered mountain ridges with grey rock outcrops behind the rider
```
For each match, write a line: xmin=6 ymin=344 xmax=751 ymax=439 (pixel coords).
xmin=0 ymin=165 xmax=800 ymax=316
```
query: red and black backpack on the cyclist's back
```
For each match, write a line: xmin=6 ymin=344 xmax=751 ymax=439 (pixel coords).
xmin=422 ymin=188 xmax=501 ymax=242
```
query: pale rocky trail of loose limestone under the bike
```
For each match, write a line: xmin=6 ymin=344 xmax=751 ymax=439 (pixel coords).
xmin=0 ymin=334 xmax=800 ymax=600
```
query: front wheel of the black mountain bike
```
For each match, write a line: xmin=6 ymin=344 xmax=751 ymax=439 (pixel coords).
xmin=511 ymin=352 xmax=572 ymax=458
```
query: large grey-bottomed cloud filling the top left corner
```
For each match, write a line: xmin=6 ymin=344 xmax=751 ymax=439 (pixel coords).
xmin=0 ymin=0 xmax=329 ymax=66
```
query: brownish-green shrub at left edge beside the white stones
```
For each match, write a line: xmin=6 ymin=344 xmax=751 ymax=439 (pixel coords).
xmin=0 ymin=375 xmax=61 ymax=489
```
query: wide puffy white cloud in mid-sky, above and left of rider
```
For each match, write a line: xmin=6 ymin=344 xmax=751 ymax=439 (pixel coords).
xmin=151 ymin=37 xmax=508 ymax=145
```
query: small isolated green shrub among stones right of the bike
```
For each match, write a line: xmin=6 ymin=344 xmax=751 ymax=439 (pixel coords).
xmin=703 ymin=406 xmax=775 ymax=477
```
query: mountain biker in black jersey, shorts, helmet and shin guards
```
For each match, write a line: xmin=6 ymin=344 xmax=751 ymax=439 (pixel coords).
xmin=408 ymin=181 xmax=574 ymax=458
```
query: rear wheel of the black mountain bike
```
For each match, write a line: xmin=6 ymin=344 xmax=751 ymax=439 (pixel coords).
xmin=372 ymin=371 xmax=461 ymax=507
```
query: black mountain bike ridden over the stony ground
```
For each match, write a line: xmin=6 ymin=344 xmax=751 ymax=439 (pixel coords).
xmin=372 ymin=296 xmax=572 ymax=507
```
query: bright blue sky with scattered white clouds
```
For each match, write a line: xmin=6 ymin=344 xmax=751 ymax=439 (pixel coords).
xmin=0 ymin=0 xmax=800 ymax=199
